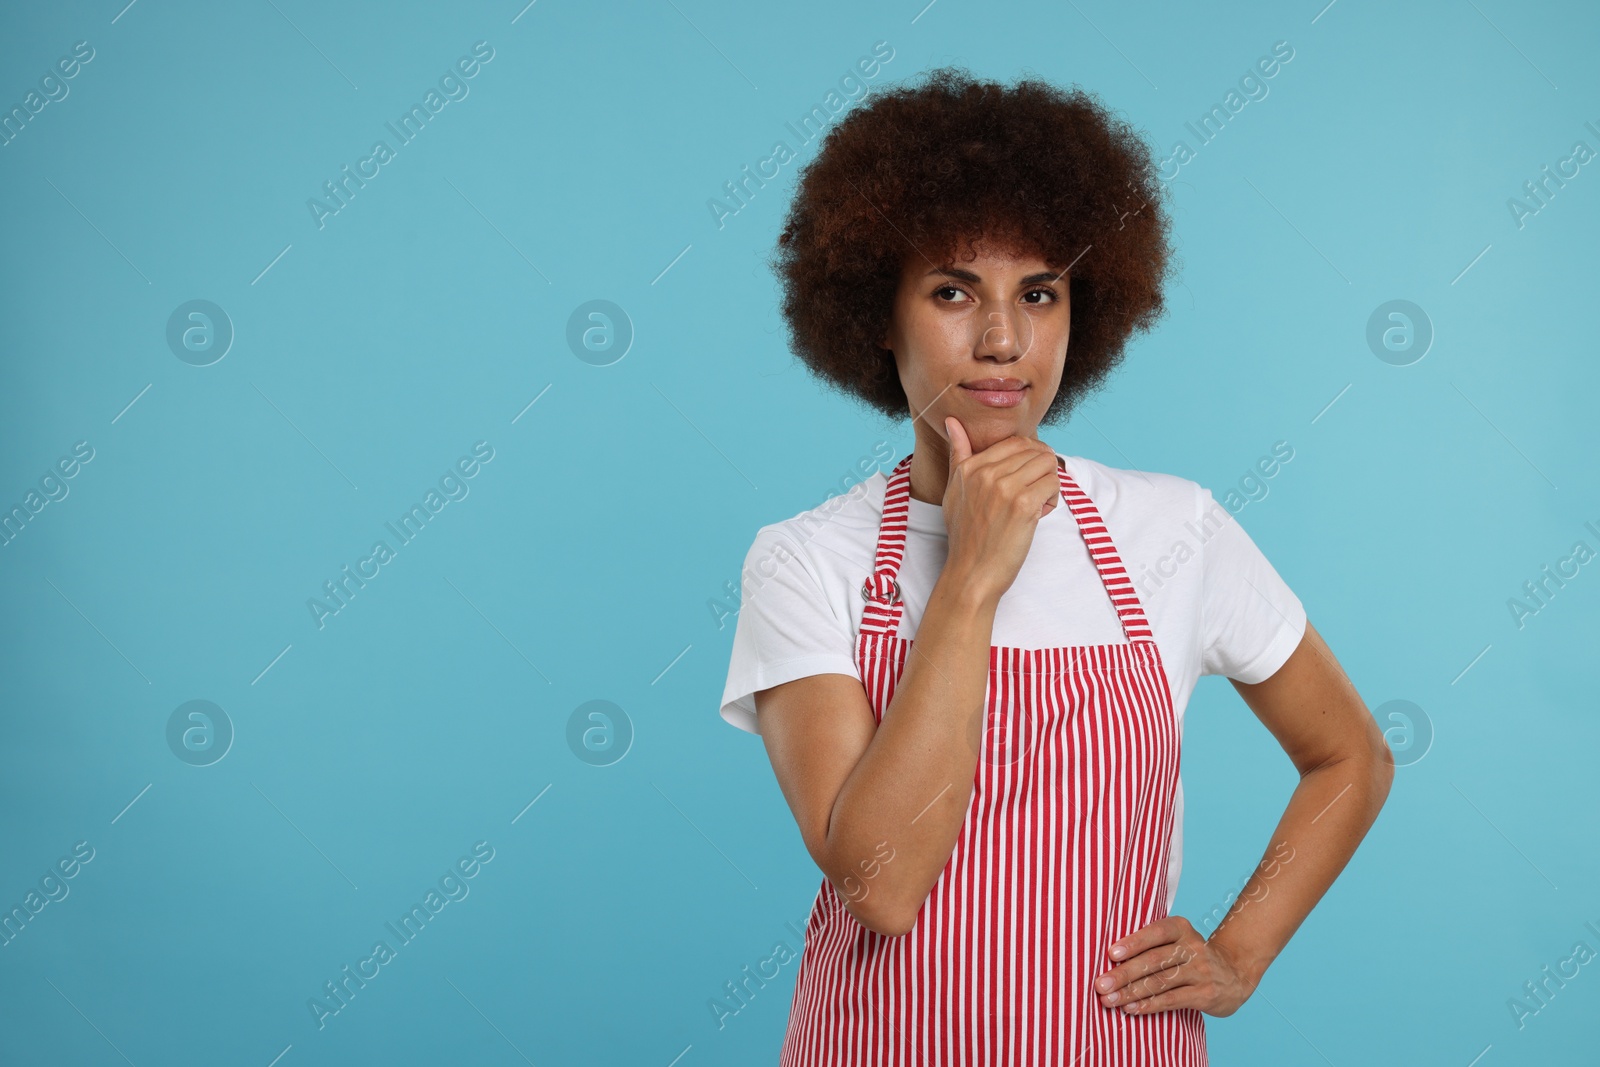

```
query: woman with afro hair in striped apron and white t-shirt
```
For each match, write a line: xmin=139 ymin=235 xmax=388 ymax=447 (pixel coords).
xmin=722 ymin=69 xmax=1394 ymax=1067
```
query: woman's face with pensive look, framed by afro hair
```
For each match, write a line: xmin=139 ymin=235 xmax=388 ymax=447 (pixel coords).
xmin=880 ymin=243 xmax=1072 ymax=453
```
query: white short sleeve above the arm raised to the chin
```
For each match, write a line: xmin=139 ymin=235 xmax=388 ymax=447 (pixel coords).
xmin=722 ymin=523 xmax=861 ymax=734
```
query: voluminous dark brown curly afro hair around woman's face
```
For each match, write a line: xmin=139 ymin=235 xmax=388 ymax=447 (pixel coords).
xmin=771 ymin=67 xmax=1173 ymax=424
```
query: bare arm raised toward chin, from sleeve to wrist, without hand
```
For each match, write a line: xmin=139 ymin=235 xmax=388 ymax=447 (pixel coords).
xmin=755 ymin=561 xmax=998 ymax=937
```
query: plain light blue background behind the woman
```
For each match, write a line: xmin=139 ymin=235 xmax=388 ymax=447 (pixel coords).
xmin=0 ymin=0 xmax=1600 ymax=1067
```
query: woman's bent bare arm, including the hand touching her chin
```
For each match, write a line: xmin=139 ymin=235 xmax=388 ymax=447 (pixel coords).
xmin=755 ymin=431 xmax=1061 ymax=937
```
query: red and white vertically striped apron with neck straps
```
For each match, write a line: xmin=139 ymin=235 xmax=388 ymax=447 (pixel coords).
xmin=779 ymin=456 xmax=1208 ymax=1067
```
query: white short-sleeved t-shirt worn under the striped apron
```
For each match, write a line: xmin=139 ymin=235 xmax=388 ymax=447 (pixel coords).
xmin=722 ymin=453 xmax=1306 ymax=909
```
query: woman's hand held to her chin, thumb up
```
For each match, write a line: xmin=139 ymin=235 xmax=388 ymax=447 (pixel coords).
xmin=944 ymin=416 xmax=1061 ymax=601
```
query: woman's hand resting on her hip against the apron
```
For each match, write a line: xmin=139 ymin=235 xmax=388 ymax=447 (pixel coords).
xmin=1094 ymin=915 xmax=1256 ymax=1016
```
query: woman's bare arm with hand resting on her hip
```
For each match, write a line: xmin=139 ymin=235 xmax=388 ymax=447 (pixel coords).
xmin=1094 ymin=622 xmax=1394 ymax=1016
